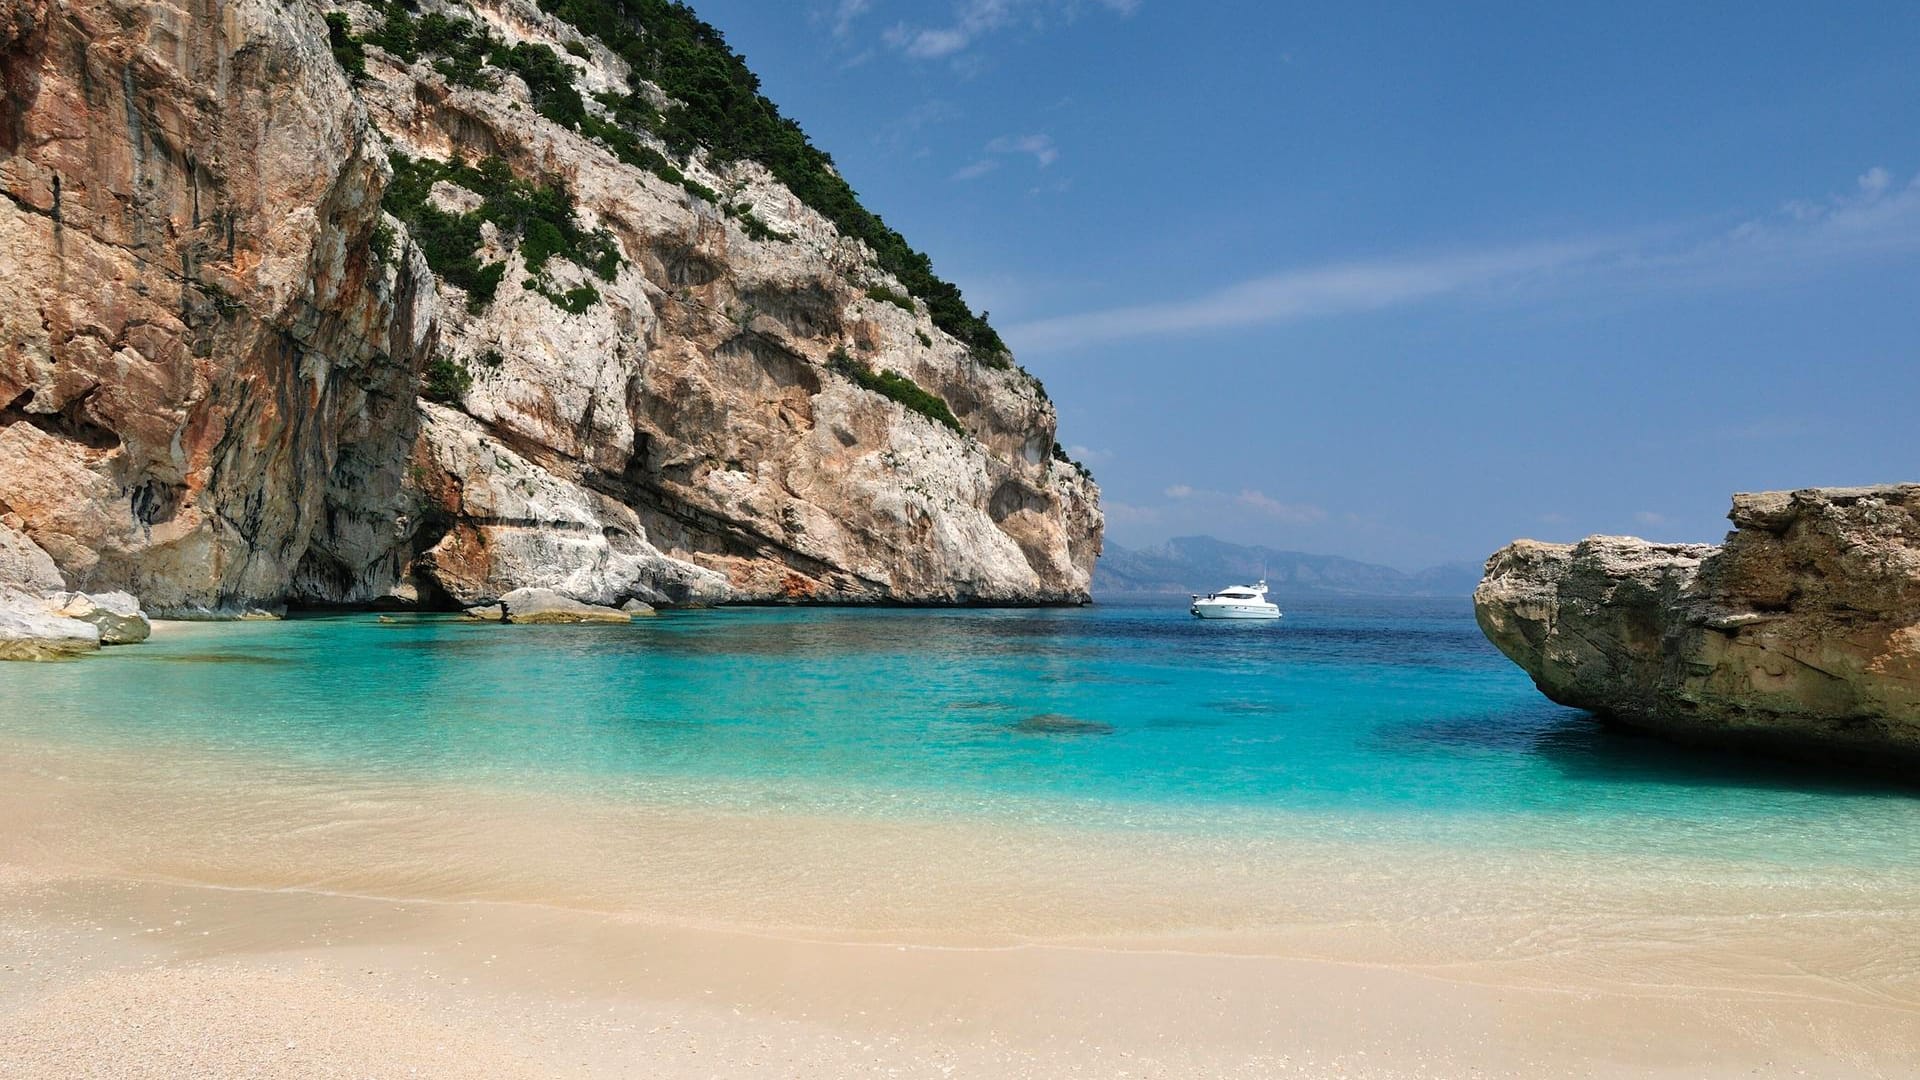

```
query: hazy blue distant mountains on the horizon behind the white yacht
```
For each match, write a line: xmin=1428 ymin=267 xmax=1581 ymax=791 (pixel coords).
xmin=1092 ymin=536 xmax=1480 ymax=598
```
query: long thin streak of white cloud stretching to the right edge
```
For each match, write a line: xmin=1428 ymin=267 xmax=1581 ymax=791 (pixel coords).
xmin=1006 ymin=167 xmax=1920 ymax=350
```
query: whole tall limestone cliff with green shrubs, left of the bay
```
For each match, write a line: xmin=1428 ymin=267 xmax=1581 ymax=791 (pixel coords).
xmin=0 ymin=0 xmax=1102 ymax=615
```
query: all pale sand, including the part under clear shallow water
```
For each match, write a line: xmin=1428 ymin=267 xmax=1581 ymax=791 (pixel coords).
xmin=0 ymin=734 xmax=1920 ymax=1076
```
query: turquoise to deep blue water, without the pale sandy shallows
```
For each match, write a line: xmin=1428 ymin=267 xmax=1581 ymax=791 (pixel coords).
xmin=0 ymin=600 xmax=1920 ymax=869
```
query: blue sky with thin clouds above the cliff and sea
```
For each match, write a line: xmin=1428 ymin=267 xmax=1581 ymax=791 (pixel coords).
xmin=693 ymin=0 xmax=1920 ymax=569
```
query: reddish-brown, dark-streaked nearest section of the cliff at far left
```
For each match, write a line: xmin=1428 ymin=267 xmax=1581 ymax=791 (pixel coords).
xmin=0 ymin=0 xmax=432 ymax=613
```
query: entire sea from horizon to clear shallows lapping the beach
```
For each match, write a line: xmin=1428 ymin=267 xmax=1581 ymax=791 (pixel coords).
xmin=0 ymin=596 xmax=1920 ymax=976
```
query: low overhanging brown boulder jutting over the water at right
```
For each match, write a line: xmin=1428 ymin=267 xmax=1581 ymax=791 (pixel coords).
xmin=1475 ymin=484 xmax=1920 ymax=776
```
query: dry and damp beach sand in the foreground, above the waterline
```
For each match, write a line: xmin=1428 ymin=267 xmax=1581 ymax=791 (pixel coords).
xmin=0 ymin=868 xmax=1920 ymax=1076
